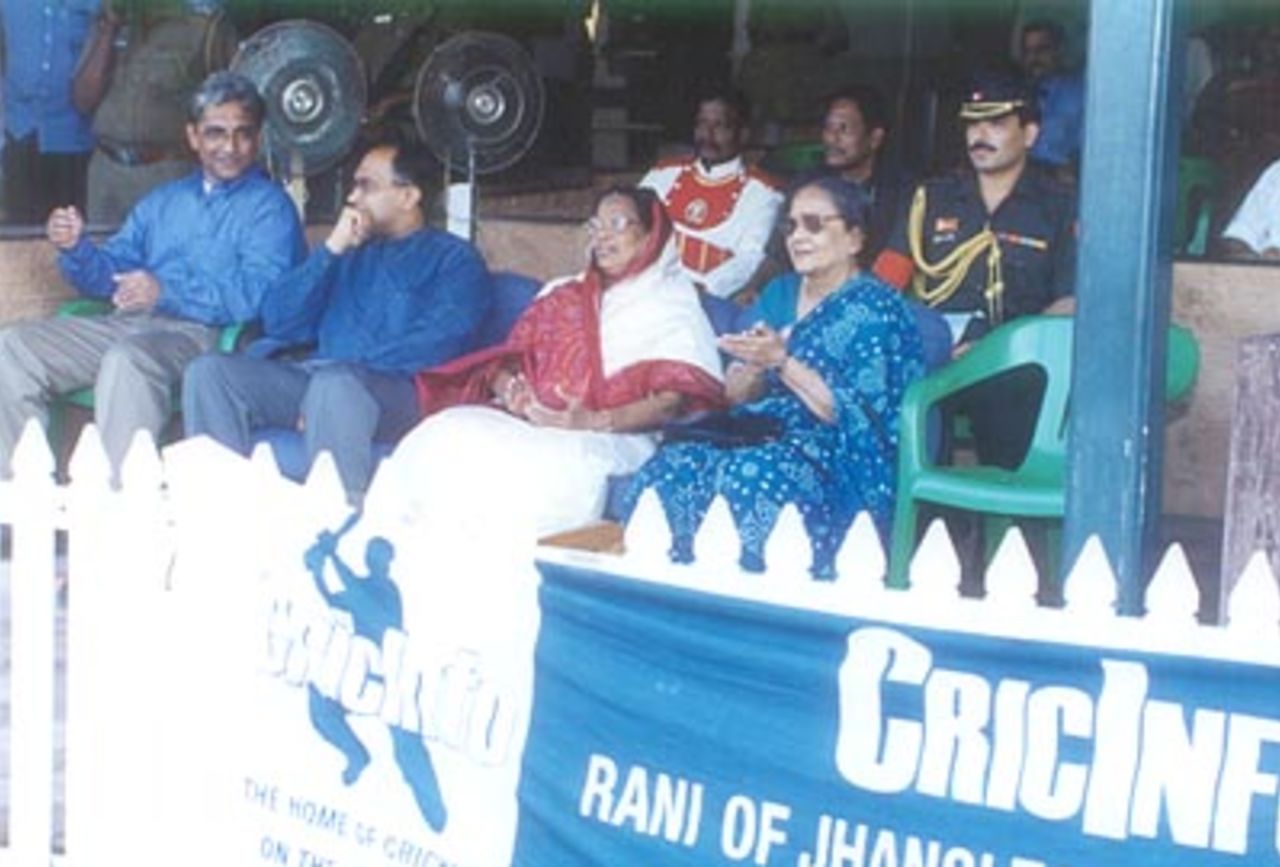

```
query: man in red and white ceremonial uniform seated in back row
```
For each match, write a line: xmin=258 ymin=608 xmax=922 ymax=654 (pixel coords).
xmin=640 ymin=91 xmax=782 ymax=298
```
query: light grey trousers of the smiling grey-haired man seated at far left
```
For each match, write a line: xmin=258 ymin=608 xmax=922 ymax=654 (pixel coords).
xmin=0 ymin=314 xmax=218 ymax=475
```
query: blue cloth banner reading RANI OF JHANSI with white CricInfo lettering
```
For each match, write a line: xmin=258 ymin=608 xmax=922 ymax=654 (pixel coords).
xmin=513 ymin=562 xmax=1280 ymax=867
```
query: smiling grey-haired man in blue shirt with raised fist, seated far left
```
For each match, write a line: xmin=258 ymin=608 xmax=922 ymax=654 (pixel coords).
xmin=0 ymin=72 xmax=306 ymax=471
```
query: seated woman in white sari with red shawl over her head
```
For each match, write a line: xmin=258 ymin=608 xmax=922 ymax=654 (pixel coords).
xmin=366 ymin=188 xmax=723 ymax=542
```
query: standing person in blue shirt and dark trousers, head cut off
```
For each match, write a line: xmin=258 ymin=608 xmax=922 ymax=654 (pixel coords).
xmin=0 ymin=0 xmax=101 ymax=223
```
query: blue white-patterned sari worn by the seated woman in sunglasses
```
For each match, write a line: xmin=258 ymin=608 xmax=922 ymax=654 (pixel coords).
xmin=625 ymin=274 xmax=924 ymax=578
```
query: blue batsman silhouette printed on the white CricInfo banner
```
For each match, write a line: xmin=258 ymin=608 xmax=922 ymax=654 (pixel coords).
xmin=302 ymin=512 xmax=448 ymax=831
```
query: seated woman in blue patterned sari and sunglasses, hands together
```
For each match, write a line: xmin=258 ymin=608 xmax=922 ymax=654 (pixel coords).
xmin=626 ymin=178 xmax=924 ymax=578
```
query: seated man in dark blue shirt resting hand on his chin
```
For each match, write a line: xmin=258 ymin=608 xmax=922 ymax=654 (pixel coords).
xmin=182 ymin=137 xmax=492 ymax=498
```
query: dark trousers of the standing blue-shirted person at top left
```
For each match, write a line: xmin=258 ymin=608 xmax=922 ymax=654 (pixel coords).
xmin=4 ymin=133 xmax=90 ymax=225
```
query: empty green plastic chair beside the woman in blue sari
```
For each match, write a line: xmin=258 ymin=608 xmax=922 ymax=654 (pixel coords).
xmin=888 ymin=316 xmax=1199 ymax=588
